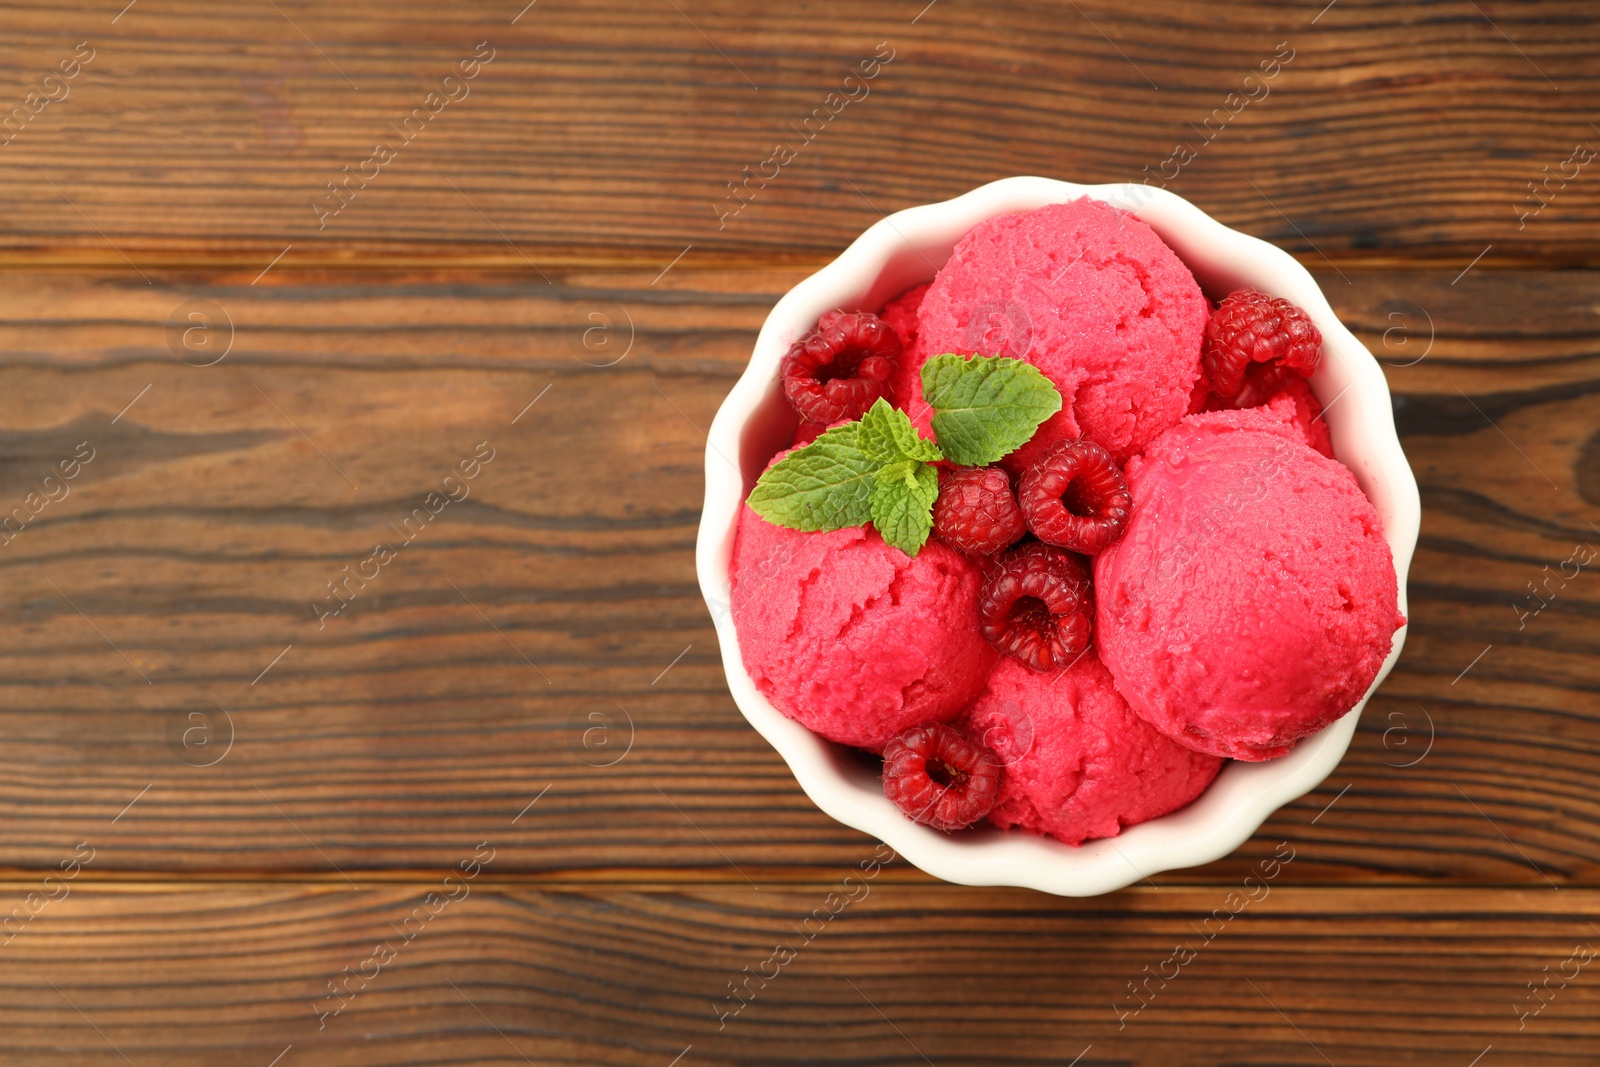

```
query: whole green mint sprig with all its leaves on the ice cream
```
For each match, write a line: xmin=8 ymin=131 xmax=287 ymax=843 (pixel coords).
xmin=749 ymin=355 xmax=1061 ymax=555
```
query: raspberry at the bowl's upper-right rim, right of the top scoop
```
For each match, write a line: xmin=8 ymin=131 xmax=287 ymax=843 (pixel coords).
xmin=1200 ymin=290 xmax=1322 ymax=408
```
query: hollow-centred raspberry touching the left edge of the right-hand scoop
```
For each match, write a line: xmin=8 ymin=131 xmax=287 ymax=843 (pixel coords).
xmin=1018 ymin=438 xmax=1133 ymax=555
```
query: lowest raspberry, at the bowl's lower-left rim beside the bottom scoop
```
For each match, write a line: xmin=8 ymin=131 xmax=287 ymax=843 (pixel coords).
xmin=883 ymin=723 xmax=1005 ymax=830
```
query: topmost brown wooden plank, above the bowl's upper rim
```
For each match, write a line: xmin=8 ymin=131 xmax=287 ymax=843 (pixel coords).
xmin=0 ymin=0 xmax=1600 ymax=274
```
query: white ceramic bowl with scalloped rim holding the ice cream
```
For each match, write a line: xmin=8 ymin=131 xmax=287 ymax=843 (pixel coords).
xmin=694 ymin=178 xmax=1421 ymax=896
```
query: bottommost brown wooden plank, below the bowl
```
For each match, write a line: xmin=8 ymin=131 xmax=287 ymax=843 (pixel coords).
xmin=0 ymin=883 xmax=1600 ymax=1067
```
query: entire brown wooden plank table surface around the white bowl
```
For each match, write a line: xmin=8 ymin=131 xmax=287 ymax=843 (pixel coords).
xmin=0 ymin=0 xmax=1600 ymax=1067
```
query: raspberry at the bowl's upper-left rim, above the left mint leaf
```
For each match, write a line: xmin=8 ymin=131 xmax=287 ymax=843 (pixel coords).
xmin=781 ymin=312 xmax=901 ymax=424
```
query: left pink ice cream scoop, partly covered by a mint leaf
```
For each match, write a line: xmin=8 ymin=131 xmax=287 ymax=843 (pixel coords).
xmin=728 ymin=506 xmax=995 ymax=752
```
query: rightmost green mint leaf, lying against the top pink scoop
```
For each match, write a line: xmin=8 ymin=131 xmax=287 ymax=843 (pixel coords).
xmin=922 ymin=354 xmax=1061 ymax=467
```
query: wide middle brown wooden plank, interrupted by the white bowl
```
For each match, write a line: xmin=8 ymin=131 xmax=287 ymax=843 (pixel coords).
xmin=0 ymin=269 xmax=1600 ymax=886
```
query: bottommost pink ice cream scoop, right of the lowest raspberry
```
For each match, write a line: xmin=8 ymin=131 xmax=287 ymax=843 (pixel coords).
xmin=965 ymin=653 xmax=1222 ymax=845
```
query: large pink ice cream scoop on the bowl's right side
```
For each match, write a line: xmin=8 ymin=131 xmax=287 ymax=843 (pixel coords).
xmin=1094 ymin=398 xmax=1405 ymax=760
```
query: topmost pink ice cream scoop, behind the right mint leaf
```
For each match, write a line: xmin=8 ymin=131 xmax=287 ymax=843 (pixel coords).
xmin=902 ymin=197 xmax=1210 ymax=470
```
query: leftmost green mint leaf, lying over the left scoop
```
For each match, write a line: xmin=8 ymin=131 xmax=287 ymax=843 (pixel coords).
xmin=749 ymin=422 xmax=882 ymax=533
